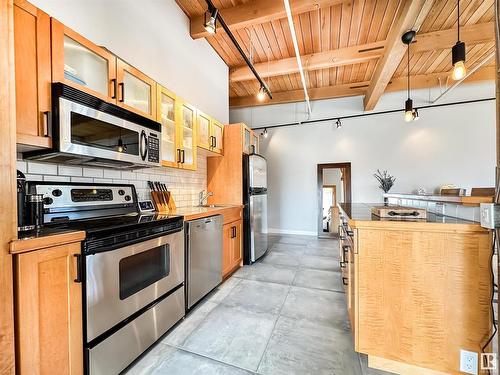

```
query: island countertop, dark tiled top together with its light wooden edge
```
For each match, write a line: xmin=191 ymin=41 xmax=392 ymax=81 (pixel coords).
xmin=338 ymin=203 xmax=487 ymax=232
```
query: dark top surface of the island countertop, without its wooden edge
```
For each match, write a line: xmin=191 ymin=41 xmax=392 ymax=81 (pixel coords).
xmin=339 ymin=203 xmax=479 ymax=226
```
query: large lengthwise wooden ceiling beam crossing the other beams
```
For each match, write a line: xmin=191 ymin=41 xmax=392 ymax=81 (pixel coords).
xmin=364 ymin=0 xmax=434 ymax=111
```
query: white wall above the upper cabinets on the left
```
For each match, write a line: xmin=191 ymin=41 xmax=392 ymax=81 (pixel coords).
xmin=31 ymin=0 xmax=229 ymax=123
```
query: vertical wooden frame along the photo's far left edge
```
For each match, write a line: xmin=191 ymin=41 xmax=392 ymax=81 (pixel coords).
xmin=0 ymin=0 xmax=17 ymax=374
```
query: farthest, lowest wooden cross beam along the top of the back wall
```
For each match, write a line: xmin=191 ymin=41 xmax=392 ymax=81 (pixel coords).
xmin=229 ymin=66 xmax=495 ymax=108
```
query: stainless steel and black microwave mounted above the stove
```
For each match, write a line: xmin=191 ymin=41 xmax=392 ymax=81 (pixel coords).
xmin=24 ymin=83 xmax=161 ymax=169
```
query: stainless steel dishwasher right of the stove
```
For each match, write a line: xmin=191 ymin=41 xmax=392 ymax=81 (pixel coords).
xmin=186 ymin=215 xmax=223 ymax=309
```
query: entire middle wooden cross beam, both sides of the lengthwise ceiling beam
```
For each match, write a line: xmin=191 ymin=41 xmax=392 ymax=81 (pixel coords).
xmin=229 ymin=22 xmax=495 ymax=82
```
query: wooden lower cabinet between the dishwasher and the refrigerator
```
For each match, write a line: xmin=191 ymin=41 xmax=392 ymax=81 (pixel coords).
xmin=222 ymin=219 xmax=243 ymax=278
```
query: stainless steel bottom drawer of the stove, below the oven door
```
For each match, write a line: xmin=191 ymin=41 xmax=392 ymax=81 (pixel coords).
xmin=89 ymin=287 xmax=185 ymax=375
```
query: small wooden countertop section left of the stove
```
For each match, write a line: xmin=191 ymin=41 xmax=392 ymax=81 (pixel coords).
xmin=10 ymin=230 xmax=85 ymax=254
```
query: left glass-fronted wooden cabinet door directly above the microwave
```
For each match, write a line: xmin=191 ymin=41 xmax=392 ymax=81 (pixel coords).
xmin=52 ymin=18 xmax=117 ymax=103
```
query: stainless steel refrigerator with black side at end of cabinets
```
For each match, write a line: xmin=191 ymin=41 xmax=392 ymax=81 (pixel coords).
xmin=243 ymin=154 xmax=268 ymax=264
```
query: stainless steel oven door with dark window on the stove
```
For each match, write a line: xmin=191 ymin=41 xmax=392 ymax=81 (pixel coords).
xmin=85 ymin=231 xmax=184 ymax=341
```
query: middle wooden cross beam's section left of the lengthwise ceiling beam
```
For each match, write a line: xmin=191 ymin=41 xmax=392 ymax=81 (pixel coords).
xmin=229 ymin=41 xmax=385 ymax=82
